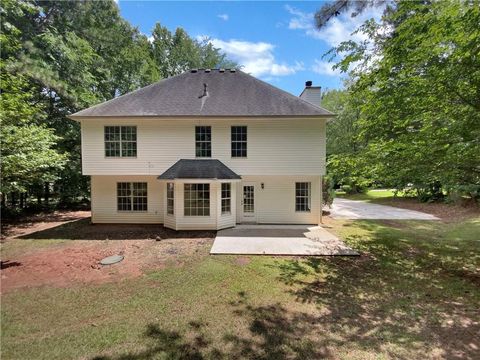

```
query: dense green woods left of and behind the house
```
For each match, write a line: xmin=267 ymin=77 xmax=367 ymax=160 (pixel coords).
xmin=0 ymin=0 xmax=234 ymax=216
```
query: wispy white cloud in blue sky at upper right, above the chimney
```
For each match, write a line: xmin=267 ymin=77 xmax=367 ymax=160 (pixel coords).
xmin=285 ymin=5 xmax=384 ymax=46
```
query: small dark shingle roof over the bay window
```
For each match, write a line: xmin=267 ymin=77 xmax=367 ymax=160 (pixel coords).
xmin=158 ymin=159 xmax=241 ymax=180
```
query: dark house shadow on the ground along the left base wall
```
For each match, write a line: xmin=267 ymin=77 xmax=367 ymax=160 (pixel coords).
xmin=17 ymin=218 xmax=215 ymax=240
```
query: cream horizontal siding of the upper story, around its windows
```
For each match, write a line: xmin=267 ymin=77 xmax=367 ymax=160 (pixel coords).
xmin=82 ymin=118 xmax=325 ymax=176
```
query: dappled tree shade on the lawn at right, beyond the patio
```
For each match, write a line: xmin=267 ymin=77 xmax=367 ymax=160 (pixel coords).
xmin=277 ymin=221 xmax=480 ymax=359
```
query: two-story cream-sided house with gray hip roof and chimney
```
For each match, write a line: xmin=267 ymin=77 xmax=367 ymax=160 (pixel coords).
xmin=71 ymin=69 xmax=332 ymax=230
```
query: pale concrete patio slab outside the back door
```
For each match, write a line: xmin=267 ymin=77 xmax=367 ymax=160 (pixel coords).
xmin=210 ymin=225 xmax=359 ymax=256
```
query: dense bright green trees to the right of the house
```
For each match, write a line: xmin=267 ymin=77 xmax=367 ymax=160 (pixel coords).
xmin=316 ymin=1 xmax=480 ymax=201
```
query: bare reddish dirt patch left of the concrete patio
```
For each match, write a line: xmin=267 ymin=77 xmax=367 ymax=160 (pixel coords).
xmin=1 ymin=239 xmax=211 ymax=293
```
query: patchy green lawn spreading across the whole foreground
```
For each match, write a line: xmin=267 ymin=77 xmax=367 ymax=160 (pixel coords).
xmin=1 ymin=218 xmax=480 ymax=359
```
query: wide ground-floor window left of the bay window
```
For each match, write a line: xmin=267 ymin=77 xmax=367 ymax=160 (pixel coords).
xmin=117 ymin=182 xmax=148 ymax=211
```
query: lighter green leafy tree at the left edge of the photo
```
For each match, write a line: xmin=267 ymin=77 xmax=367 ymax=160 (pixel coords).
xmin=0 ymin=71 xmax=66 ymax=196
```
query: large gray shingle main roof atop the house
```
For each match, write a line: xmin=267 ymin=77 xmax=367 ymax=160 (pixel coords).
xmin=70 ymin=69 xmax=332 ymax=118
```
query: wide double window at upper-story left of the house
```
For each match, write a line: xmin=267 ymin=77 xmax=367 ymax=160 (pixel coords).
xmin=105 ymin=126 xmax=137 ymax=157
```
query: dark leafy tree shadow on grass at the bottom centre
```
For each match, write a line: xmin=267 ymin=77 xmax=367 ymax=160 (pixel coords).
xmin=92 ymin=292 xmax=332 ymax=360
